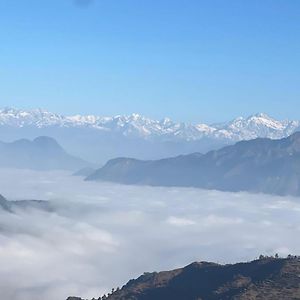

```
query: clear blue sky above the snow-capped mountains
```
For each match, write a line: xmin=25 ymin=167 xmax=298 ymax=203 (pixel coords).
xmin=0 ymin=0 xmax=300 ymax=122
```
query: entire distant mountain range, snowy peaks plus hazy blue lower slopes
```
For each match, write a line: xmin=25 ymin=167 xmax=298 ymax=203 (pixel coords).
xmin=0 ymin=108 xmax=300 ymax=163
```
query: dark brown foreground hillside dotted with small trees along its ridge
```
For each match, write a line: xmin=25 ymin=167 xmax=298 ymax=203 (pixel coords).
xmin=69 ymin=258 xmax=300 ymax=300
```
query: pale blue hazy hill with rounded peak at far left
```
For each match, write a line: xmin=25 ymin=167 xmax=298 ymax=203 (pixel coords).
xmin=0 ymin=136 xmax=90 ymax=170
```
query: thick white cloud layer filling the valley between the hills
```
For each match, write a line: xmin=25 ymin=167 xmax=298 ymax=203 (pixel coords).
xmin=0 ymin=170 xmax=300 ymax=300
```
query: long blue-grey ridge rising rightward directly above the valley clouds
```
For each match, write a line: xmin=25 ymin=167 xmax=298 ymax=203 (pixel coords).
xmin=87 ymin=133 xmax=300 ymax=196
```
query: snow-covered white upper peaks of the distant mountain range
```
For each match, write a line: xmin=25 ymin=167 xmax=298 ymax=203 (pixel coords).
xmin=0 ymin=108 xmax=300 ymax=141
